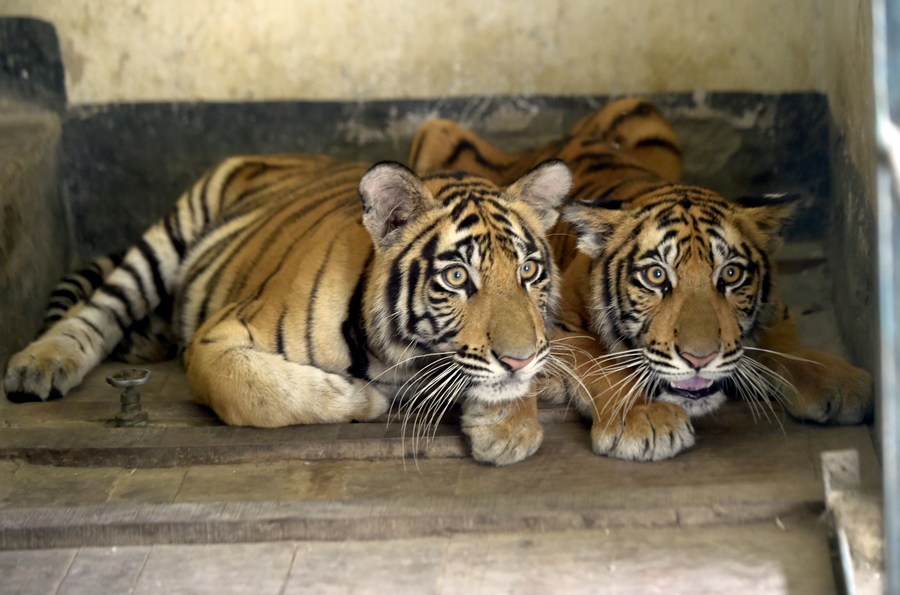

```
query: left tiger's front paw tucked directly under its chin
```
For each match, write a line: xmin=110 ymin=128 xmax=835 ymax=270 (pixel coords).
xmin=462 ymin=398 xmax=544 ymax=465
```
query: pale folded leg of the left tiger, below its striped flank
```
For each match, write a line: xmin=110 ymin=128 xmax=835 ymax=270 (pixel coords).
xmin=185 ymin=321 xmax=389 ymax=428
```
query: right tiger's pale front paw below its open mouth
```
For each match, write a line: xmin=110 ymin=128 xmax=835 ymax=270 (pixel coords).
xmin=591 ymin=402 xmax=694 ymax=461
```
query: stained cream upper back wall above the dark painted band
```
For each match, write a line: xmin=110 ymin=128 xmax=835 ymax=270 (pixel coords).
xmin=0 ymin=0 xmax=824 ymax=104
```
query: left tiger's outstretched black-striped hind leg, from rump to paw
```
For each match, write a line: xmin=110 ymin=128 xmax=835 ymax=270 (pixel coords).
xmin=4 ymin=156 xmax=325 ymax=401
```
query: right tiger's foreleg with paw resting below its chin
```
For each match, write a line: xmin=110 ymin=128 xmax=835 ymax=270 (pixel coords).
xmin=554 ymin=331 xmax=694 ymax=461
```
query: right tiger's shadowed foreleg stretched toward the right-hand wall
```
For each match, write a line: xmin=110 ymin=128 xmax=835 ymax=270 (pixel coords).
xmin=752 ymin=317 xmax=874 ymax=424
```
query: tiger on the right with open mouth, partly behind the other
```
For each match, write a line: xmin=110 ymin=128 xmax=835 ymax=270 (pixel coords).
xmin=408 ymin=97 xmax=873 ymax=461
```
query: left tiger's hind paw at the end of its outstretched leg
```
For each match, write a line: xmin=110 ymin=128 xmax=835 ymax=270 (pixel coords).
xmin=3 ymin=337 xmax=86 ymax=403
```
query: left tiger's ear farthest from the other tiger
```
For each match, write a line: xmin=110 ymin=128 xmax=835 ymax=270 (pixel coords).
xmin=359 ymin=161 xmax=434 ymax=247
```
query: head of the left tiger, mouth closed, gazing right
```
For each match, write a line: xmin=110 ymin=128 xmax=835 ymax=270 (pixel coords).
xmin=360 ymin=161 xmax=571 ymax=402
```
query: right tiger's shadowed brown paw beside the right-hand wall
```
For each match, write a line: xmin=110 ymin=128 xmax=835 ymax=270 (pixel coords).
xmin=784 ymin=357 xmax=875 ymax=424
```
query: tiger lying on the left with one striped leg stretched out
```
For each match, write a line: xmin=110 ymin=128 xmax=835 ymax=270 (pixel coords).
xmin=4 ymin=155 xmax=572 ymax=465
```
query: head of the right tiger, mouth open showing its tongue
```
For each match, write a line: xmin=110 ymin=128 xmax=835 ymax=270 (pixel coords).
xmin=564 ymin=184 xmax=794 ymax=416
